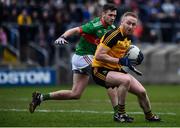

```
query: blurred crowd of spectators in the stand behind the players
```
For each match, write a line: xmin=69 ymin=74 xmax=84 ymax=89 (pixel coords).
xmin=0 ymin=0 xmax=180 ymax=66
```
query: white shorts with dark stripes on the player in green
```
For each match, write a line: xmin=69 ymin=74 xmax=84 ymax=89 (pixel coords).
xmin=72 ymin=54 xmax=93 ymax=74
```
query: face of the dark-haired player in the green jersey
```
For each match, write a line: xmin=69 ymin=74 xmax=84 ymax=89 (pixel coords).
xmin=103 ymin=10 xmax=117 ymax=25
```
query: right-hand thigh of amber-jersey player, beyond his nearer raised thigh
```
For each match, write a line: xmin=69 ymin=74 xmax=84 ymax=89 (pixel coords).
xmin=129 ymin=74 xmax=146 ymax=95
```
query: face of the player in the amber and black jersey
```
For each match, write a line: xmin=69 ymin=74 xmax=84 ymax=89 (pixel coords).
xmin=121 ymin=16 xmax=138 ymax=35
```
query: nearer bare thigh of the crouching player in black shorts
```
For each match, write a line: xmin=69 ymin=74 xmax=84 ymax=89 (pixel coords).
xmin=106 ymin=71 xmax=131 ymax=86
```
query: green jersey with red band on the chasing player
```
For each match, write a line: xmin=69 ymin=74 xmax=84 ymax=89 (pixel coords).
xmin=75 ymin=17 xmax=115 ymax=56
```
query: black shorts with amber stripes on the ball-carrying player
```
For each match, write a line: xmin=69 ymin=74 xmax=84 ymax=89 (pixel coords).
xmin=92 ymin=67 xmax=126 ymax=88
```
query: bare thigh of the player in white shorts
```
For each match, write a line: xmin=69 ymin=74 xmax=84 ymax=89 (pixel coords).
xmin=72 ymin=73 xmax=89 ymax=93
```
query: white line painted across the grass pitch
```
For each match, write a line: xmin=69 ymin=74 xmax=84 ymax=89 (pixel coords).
xmin=0 ymin=109 xmax=176 ymax=116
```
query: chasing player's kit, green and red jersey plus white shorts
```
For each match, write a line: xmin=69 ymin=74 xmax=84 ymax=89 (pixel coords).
xmin=72 ymin=17 xmax=115 ymax=75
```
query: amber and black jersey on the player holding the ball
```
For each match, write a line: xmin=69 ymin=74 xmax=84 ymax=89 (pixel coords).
xmin=92 ymin=28 xmax=131 ymax=70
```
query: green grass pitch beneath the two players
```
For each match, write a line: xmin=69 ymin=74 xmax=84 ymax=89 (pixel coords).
xmin=0 ymin=85 xmax=180 ymax=127
